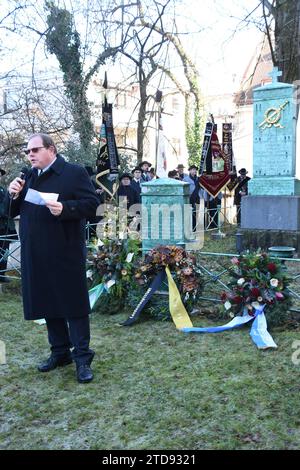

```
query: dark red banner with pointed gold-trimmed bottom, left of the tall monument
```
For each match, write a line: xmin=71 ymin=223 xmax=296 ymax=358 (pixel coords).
xmin=199 ymin=129 xmax=230 ymax=197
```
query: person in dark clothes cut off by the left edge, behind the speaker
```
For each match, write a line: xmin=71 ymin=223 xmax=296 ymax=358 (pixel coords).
xmin=0 ymin=168 xmax=15 ymax=283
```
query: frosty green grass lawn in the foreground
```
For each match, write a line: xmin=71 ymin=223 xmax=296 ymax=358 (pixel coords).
xmin=0 ymin=282 xmax=300 ymax=450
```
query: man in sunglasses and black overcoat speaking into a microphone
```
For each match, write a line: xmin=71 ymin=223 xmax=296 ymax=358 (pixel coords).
xmin=8 ymin=134 xmax=98 ymax=383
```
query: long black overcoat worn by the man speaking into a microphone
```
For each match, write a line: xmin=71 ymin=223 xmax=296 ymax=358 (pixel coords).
xmin=11 ymin=155 xmax=98 ymax=320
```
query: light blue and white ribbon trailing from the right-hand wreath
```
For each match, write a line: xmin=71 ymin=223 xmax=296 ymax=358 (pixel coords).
xmin=181 ymin=305 xmax=277 ymax=349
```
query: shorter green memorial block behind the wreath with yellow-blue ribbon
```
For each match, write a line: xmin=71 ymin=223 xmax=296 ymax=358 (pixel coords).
xmin=142 ymin=178 xmax=191 ymax=253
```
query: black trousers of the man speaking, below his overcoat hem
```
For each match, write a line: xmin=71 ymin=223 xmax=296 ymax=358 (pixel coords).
xmin=46 ymin=316 xmax=95 ymax=366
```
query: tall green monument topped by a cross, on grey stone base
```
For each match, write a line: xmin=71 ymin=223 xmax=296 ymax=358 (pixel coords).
xmin=241 ymin=67 xmax=300 ymax=249
